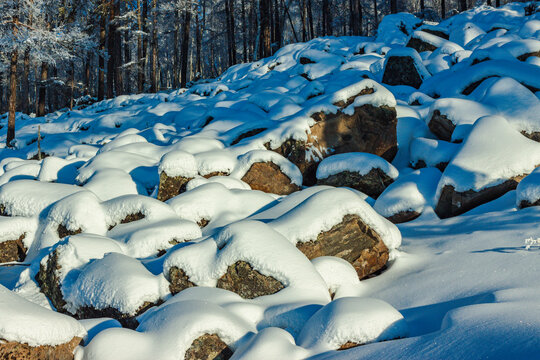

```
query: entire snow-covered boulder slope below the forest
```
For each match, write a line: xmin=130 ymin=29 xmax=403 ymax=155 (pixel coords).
xmin=0 ymin=2 xmax=540 ymax=360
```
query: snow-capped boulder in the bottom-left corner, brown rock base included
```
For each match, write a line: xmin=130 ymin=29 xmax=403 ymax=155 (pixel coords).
xmin=0 ymin=285 xmax=86 ymax=360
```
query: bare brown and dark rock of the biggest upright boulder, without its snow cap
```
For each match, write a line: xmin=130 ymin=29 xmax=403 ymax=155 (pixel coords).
xmin=267 ymin=102 xmax=397 ymax=185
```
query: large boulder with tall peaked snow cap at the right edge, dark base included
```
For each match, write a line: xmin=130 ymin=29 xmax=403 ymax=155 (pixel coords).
xmin=435 ymin=116 xmax=540 ymax=218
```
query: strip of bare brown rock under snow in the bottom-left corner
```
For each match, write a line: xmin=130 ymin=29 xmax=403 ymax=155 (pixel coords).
xmin=0 ymin=337 xmax=82 ymax=360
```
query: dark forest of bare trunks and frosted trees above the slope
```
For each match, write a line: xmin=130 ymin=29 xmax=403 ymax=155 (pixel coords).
xmin=0 ymin=0 xmax=516 ymax=144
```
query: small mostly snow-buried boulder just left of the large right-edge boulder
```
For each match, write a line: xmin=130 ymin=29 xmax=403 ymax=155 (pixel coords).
xmin=373 ymin=168 xmax=441 ymax=224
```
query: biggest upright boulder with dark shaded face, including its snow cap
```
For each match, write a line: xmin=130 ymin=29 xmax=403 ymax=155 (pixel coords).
xmin=267 ymin=79 xmax=397 ymax=185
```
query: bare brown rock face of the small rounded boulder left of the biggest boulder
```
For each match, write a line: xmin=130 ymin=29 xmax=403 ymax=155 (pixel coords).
xmin=242 ymin=162 xmax=300 ymax=195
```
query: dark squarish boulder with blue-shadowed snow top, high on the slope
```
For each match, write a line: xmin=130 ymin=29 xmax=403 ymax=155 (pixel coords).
xmin=382 ymin=47 xmax=431 ymax=89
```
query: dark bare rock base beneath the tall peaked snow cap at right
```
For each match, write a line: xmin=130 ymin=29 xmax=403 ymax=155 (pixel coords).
xmin=435 ymin=175 xmax=525 ymax=219
